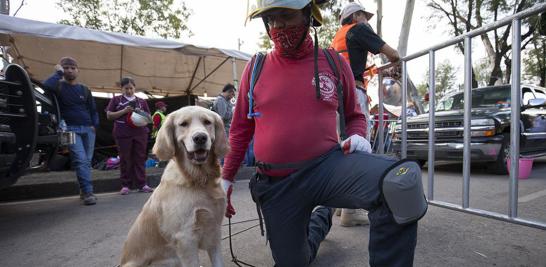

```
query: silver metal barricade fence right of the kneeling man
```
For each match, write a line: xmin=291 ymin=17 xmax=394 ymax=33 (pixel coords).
xmin=374 ymin=3 xmax=546 ymax=230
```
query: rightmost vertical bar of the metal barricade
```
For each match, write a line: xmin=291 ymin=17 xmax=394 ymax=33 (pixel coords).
xmin=508 ymin=19 xmax=523 ymax=218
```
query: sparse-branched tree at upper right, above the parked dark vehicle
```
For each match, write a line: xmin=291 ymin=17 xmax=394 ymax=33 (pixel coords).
xmin=428 ymin=0 xmax=543 ymax=86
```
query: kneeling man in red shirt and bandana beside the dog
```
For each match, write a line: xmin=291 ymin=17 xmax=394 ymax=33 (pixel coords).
xmin=222 ymin=0 xmax=420 ymax=267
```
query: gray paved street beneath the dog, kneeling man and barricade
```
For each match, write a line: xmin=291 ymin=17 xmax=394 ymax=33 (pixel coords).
xmin=0 ymin=159 xmax=546 ymax=267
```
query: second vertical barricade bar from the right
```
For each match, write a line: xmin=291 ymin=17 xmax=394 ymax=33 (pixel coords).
xmin=463 ymin=37 xmax=472 ymax=209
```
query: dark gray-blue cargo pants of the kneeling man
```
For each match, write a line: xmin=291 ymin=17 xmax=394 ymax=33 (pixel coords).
xmin=250 ymin=146 xmax=417 ymax=267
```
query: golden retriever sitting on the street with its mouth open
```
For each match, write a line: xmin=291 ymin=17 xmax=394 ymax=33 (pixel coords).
xmin=121 ymin=106 xmax=228 ymax=267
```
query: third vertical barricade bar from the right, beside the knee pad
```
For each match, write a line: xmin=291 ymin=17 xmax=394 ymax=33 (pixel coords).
xmin=428 ymin=50 xmax=436 ymax=200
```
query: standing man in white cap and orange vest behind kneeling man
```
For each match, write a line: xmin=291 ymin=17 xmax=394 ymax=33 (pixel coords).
xmin=331 ymin=2 xmax=400 ymax=226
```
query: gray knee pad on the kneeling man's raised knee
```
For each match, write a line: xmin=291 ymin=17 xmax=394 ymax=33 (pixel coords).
xmin=379 ymin=160 xmax=428 ymax=224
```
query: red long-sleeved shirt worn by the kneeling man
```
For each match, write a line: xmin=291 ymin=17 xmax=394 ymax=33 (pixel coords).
xmin=219 ymin=49 xmax=366 ymax=180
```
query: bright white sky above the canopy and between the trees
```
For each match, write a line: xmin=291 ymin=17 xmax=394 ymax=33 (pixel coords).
xmin=11 ymin=0 xmax=472 ymax=86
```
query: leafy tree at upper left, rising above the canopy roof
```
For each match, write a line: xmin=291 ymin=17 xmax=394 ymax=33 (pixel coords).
xmin=57 ymin=0 xmax=191 ymax=38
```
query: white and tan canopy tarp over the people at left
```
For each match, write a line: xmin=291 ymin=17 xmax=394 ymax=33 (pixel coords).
xmin=0 ymin=15 xmax=250 ymax=96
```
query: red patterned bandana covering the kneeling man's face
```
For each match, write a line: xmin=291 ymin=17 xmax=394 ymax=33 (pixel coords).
xmin=269 ymin=25 xmax=313 ymax=59
